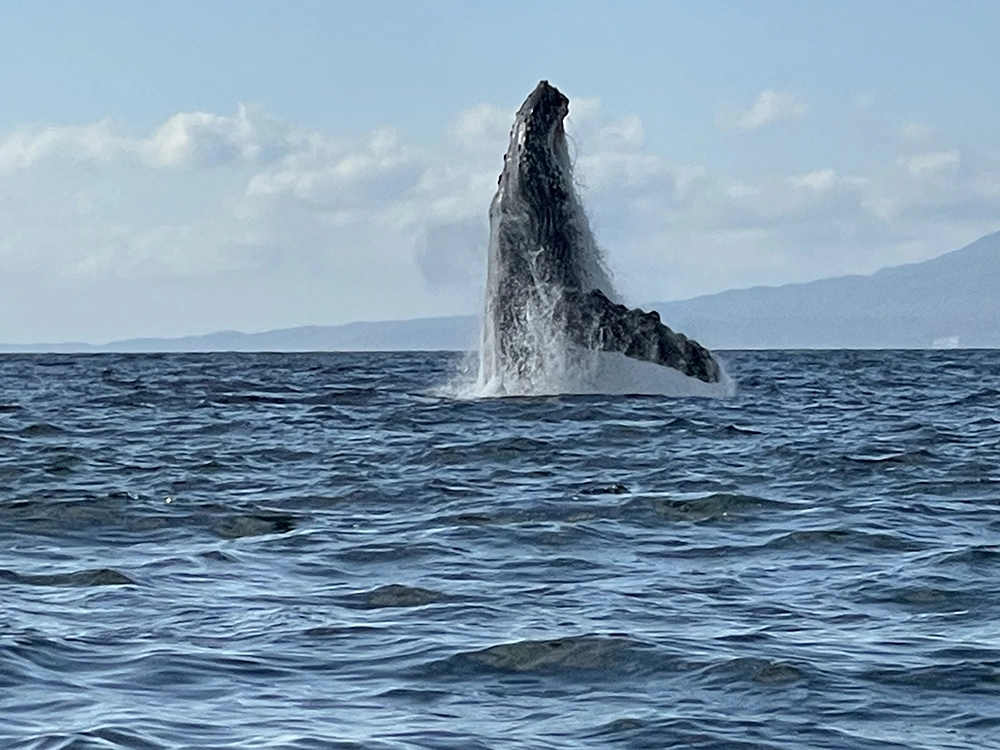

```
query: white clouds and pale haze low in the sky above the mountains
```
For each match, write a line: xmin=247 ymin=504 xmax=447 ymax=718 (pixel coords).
xmin=0 ymin=90 xmax=1000 ymax=343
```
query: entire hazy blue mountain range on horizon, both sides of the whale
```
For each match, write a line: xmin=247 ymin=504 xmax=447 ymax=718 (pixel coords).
xmin=7 ymin=232 xmax=1000 ymax=352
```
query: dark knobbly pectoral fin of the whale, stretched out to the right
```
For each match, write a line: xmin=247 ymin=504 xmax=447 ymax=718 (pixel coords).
xmin=560 ymin=289 xmax=719 ymax=383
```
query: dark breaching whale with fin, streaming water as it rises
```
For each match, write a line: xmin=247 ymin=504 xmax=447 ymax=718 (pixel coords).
xmin=479 ymin=81 xmax=724 ymax=400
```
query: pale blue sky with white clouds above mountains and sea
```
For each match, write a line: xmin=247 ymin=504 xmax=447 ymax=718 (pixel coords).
xmin=0 ymin=0 xmax=1000 ymax=343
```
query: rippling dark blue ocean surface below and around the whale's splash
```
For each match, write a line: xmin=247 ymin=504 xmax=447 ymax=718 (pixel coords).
xmin=0 ymin=351 xmax=1000 ymax=750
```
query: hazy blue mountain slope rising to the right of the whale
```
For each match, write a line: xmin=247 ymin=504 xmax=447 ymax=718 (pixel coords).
xmin=652 ymin=232 xmax=1000 ymax=349
